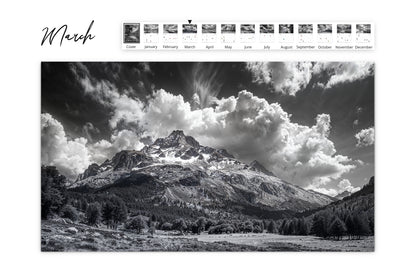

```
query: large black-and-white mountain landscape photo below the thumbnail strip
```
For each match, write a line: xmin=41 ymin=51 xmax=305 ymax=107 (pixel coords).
xmin=41 ymin=62 xmax=375 ymax=251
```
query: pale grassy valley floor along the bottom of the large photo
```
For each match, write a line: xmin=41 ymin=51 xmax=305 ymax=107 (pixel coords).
xmin=41 ymin=220 xmax=374 ymax=252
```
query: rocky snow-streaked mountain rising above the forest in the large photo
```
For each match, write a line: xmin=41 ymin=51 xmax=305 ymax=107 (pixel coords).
xmin=70 ymin=130 xmax=333 ymax=211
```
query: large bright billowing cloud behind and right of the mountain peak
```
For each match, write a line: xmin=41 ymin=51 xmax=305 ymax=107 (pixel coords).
xmin=128 ymin=90 xmax=355 ymax=186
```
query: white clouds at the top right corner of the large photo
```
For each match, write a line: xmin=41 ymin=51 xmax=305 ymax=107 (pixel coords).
xmin=246 ymin=62 xmax=374 ymax=95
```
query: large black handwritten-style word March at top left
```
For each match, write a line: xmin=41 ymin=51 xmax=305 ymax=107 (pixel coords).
xmin=40 ymin=20 xmax=95 ymax=46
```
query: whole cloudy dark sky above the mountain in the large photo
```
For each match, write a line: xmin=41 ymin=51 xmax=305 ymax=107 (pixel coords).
xmin=41 ymin=62 xmax=375 ymax=195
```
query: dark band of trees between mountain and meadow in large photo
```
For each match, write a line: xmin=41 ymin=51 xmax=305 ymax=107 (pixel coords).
xmin=41 ymin=166 xmax=374 ymax=239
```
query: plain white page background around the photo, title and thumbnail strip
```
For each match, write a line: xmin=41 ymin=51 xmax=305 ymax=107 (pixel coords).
xmin=0 ymin=0 xmax=416 ymax=277
